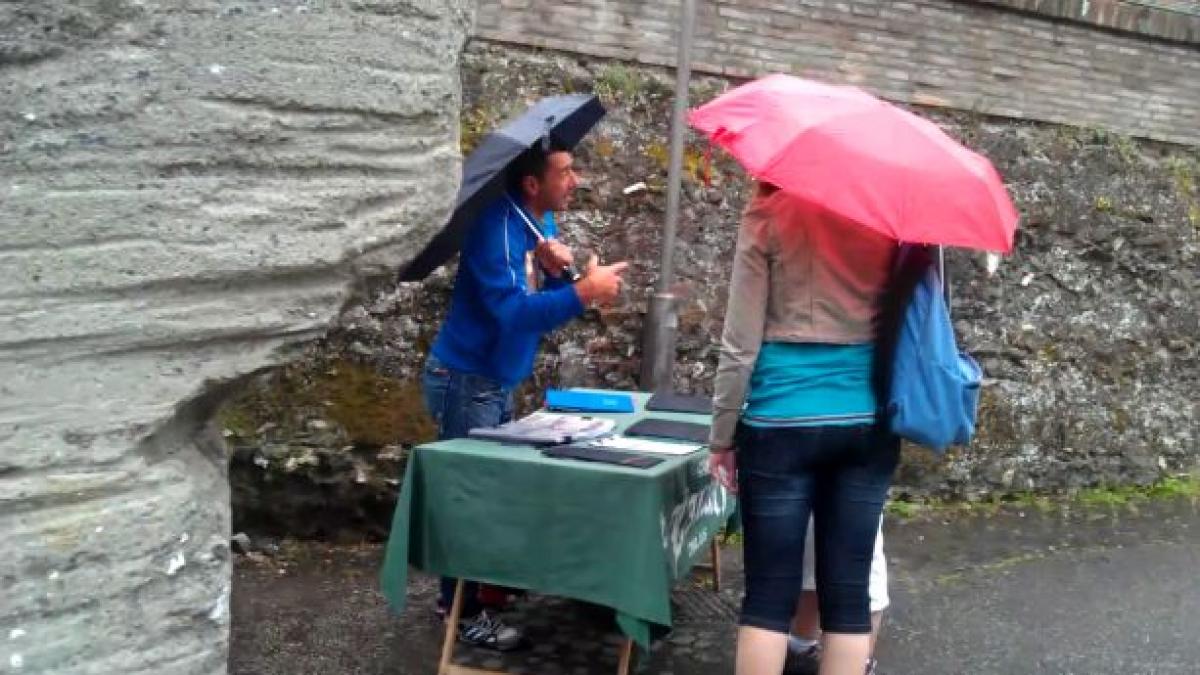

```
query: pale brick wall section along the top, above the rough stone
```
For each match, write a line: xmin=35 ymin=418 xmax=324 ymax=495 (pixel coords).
xmin=475 ymin=0 xmax=1200 ymax=144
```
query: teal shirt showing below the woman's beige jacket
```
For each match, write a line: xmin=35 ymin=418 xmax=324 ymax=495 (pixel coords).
xmin=742 ymin=342 xmax=876 ymax=426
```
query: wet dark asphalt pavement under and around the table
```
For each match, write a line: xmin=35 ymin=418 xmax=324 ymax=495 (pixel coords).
xmin=229 ymin=500 xmax=1200 ymax=675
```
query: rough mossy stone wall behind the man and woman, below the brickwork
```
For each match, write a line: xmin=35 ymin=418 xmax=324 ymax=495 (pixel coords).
xmin=220 ymin=41 xmax=1200 ymax=537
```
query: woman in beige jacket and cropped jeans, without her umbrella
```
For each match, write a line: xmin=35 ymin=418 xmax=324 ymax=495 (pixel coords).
xmin=712 ymin=184 xmax=899 ymax=675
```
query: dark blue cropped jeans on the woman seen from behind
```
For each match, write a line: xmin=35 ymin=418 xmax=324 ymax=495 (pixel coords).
xmin=737 ymin=425 xmax=900 ymax=634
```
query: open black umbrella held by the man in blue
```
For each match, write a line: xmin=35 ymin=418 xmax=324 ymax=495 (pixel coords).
xmin=400 ymin=94 xmax=605 ymax=281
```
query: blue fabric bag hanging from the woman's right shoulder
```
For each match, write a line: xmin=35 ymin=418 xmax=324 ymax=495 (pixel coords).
xmin=886 ymin=246 xmax=983 ymax=454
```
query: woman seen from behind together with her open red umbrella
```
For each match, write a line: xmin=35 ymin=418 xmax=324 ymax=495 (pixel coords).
xmin=691 ymin=76 xmax=1016 ymax=675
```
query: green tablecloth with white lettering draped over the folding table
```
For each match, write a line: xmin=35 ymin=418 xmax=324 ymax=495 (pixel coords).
xmin=382 ymin=393 xmax=736 ymax=647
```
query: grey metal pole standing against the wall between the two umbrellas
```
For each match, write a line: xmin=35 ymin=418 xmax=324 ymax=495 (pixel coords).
xmin=641 ymin=0 xmax=696 ymax=392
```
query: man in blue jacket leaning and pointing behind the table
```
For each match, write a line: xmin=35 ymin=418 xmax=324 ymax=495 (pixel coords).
xmin=424 ymin=99 xmax=626 ymax=651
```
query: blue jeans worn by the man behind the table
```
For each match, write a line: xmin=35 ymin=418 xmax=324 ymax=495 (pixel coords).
xmin=421 ymin=354 xmax=512 ymax=617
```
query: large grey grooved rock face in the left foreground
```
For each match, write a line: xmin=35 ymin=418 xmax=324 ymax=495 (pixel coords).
xmin=0 ymin=0 xmax=473 ymax=675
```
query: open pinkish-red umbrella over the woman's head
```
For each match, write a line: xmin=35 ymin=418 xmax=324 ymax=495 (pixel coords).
xmin=690 ymin=74 xmax=1018 ymax=253
